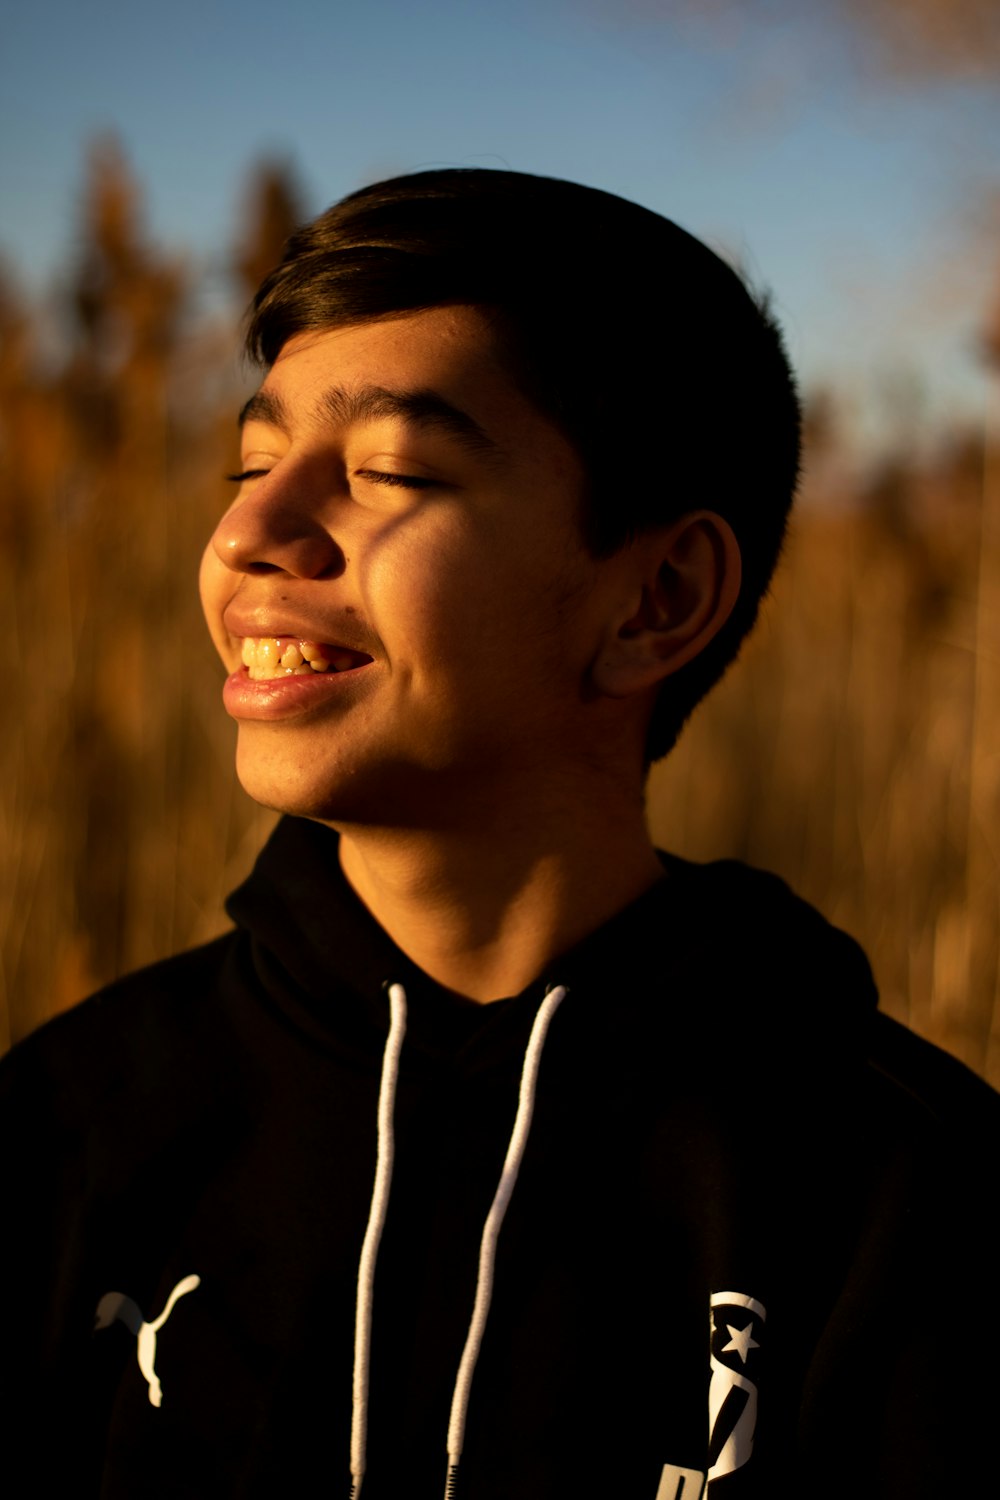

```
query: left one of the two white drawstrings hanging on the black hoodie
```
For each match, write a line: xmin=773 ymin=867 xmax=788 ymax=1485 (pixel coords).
xmin=351 ymin=984 xmax=406 ymax=1500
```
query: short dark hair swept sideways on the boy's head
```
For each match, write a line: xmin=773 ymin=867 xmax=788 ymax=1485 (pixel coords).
xmin=246 ymin=168 xmax=799 ymax=761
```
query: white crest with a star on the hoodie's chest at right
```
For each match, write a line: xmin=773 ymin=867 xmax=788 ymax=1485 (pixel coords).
xmin=708 ymin=1292 xmax=768 ymax=1485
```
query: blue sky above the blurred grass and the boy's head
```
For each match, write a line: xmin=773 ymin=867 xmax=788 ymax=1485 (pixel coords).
xmin=0 ymin=0 xmax=1000 ymax=450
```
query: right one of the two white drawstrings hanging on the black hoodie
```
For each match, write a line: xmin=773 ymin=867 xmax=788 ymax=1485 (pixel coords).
xmin=444 ymin=984 xmax=567 ymax=1500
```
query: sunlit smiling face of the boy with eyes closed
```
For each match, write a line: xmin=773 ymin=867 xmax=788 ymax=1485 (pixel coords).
xmin=201 ymin=308 xmax=620 ymax=827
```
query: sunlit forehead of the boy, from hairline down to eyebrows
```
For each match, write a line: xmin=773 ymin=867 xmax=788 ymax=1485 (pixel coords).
xmin=240 ymin=308 xmax=576 ymax=464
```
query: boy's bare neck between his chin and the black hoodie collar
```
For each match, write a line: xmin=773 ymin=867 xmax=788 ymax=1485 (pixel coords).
xmin=339 ymin=785 xmax=663 ymax=1002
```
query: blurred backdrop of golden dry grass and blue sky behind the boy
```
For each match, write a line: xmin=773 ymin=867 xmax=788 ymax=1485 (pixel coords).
xmin=0 ymin=0 xmax=1000 ymax=1083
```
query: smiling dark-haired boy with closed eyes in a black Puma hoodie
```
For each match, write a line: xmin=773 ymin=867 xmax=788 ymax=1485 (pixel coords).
xmin=3 ymin=171 xmax=997 ymax=1500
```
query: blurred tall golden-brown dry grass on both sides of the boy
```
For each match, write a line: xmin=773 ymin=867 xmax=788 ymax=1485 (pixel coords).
xmin=0 ymin=149 xmax=1000 ymax=1083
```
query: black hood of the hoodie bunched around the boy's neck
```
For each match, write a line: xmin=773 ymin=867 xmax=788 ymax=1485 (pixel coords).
xmin=226 ymin=818 xmax=877 ymax=1052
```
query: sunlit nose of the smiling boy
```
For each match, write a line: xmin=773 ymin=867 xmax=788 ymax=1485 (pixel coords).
xmin=211 ymin=471 xmax=345 ymax=578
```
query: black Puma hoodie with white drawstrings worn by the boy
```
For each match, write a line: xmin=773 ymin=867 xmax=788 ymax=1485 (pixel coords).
xmin=0 ymin=819 xmax=1000 ymax=1500
